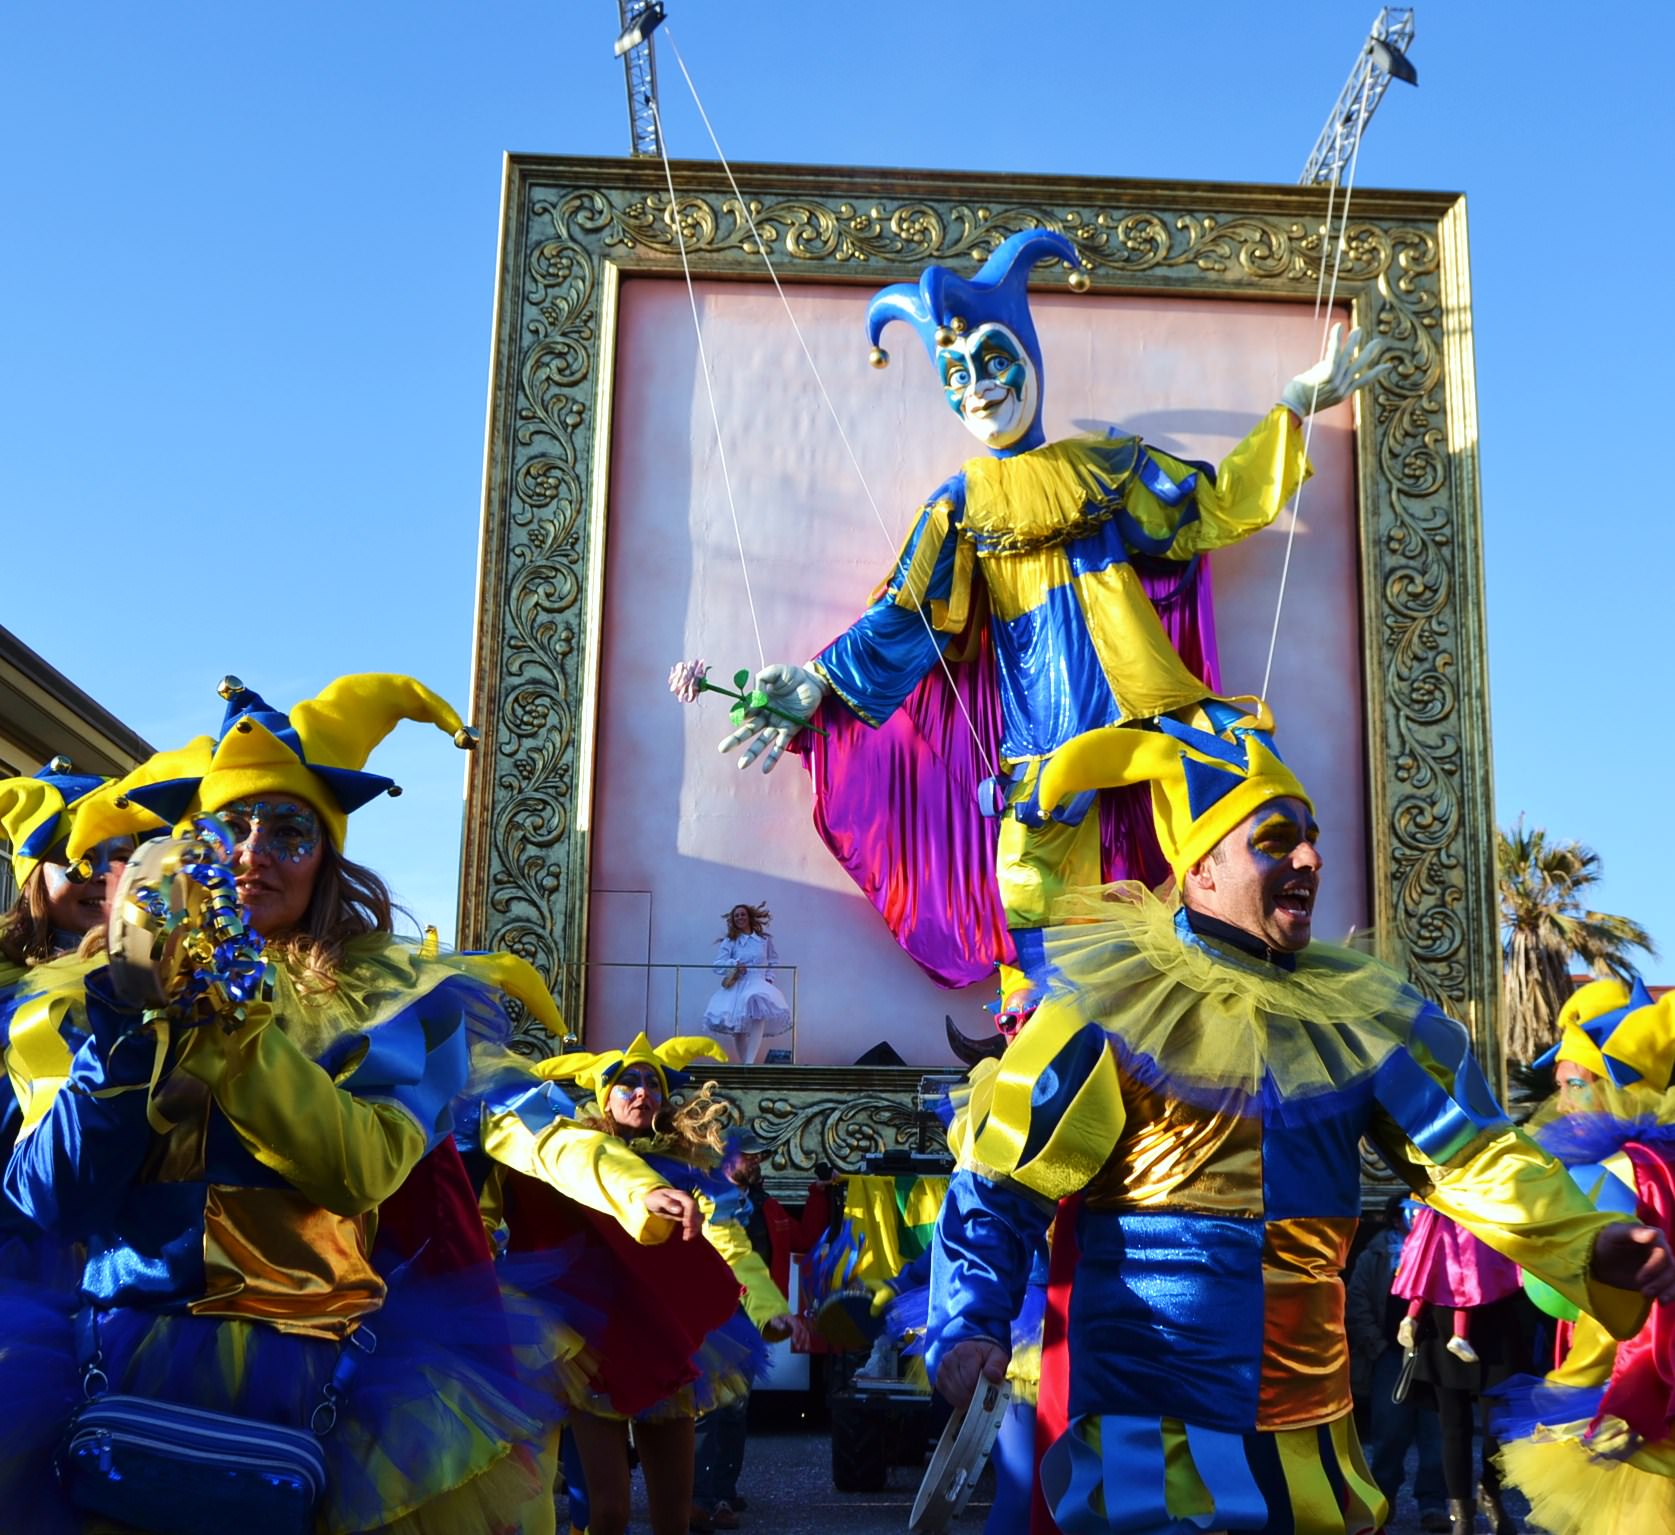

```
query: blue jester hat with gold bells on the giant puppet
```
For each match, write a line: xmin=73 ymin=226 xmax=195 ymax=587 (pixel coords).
xmin=866 ymin=230 xmax=1087 ymax=456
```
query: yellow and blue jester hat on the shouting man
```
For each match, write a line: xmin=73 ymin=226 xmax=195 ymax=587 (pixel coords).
xmin=1040 ymin=699 xmax=1315 ymax=883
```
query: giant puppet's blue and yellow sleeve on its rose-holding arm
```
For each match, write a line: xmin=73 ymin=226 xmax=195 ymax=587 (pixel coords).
xmin=814 ymin=474 xmax=977 ymax=726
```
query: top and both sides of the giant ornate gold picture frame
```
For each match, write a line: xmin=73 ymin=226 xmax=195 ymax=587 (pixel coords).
xmin=461 ymin=156 xmax=1501 ymax=1106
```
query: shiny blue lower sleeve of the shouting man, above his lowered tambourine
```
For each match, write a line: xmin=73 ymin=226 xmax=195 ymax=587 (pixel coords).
xmin=925 ymin=1168 xmax=1055 ymax=1381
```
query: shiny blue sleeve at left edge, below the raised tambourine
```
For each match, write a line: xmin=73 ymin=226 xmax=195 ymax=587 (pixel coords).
xmin=5 ymin=970 xmax=157 ymax=1237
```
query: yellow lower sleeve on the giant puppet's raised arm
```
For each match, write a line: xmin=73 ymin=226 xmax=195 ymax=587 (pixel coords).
xmin=1127 ymin=406 xmax=1313 ymax=560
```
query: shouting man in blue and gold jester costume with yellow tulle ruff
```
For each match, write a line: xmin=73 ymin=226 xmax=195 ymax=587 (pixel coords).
xmin=928 ymin=700 xmax=1675 ymax=1535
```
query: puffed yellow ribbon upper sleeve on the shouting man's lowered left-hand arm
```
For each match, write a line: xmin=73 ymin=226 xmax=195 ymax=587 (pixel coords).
xmin=961 ymin=1000 xmax=1127 ymax=1200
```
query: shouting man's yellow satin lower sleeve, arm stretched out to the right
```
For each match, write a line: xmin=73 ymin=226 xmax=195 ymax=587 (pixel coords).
xmin=1372 ymin=1111 xmax=1650 ymax=1337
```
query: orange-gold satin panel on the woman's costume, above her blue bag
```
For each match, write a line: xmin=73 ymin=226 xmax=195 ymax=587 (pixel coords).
xmin=191 ymin=1183 xmax=384 ymax=1337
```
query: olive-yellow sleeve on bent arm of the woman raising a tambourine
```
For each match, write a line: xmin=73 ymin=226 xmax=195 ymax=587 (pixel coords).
xmin=176 ymin=1016 xmax=427 ymax=1215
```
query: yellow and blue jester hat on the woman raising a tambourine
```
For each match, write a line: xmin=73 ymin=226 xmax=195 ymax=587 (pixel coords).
xmin=69 ymin=672 xmax=477 ymax=858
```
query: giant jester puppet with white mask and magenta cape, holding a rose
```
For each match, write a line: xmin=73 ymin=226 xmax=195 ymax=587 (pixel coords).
xmin=722 ymin=230 xmax=1385 ymax=999
